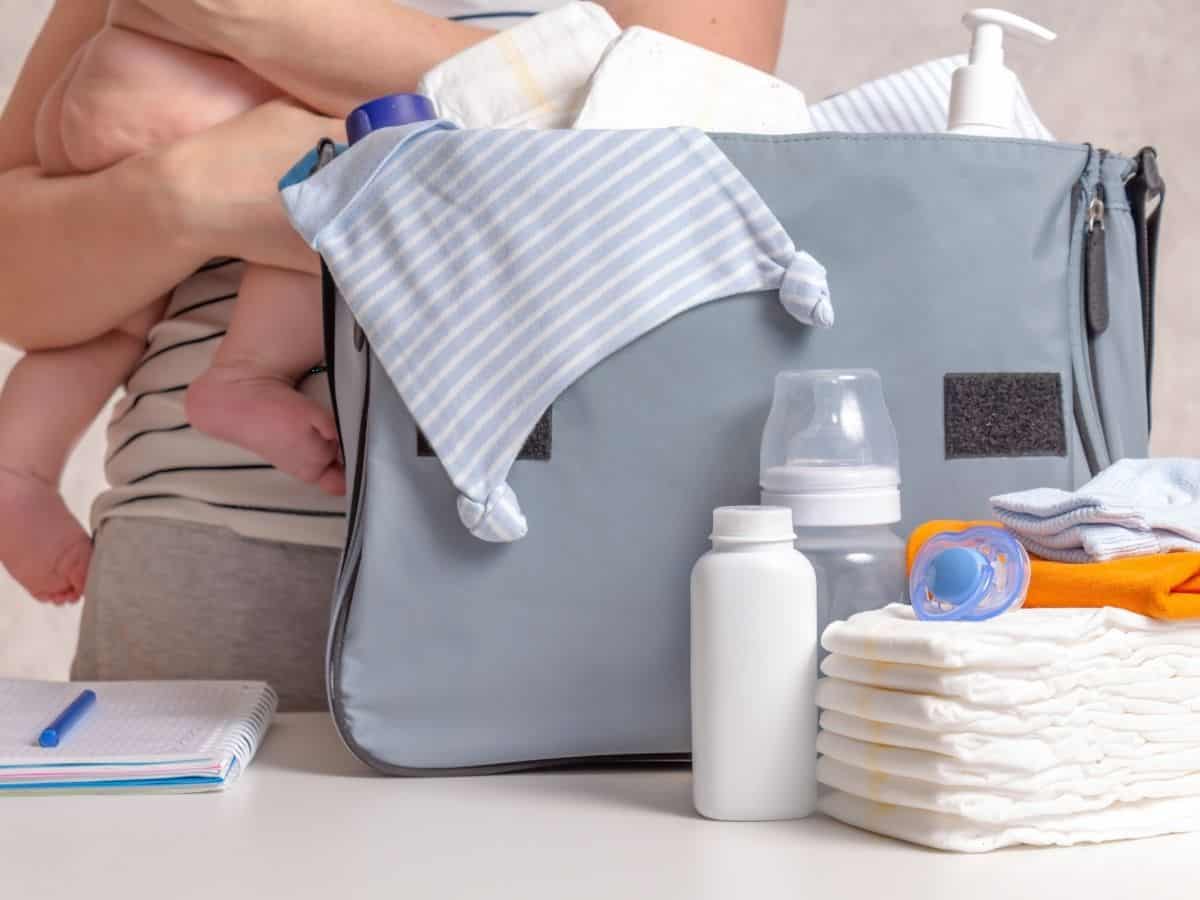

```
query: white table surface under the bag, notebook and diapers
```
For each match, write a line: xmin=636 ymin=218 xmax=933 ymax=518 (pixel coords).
xmin=0 ymin=714 xmax=1200 ymax=900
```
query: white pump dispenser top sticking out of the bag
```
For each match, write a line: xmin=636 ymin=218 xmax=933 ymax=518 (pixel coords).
xmin=949 ymin=10 xmax=1056 ymax=137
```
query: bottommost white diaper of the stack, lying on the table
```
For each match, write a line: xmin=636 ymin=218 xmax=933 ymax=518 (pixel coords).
xmin=818 ymin=791 xmax=1200 ymax=853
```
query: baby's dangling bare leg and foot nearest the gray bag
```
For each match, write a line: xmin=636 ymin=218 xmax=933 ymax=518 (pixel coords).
xmin=187 ymin=266 xmax=346 ymax=494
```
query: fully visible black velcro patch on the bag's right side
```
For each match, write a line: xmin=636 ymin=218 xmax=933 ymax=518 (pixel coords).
xmin=943 ymin=372 xmax=1067 ymax=460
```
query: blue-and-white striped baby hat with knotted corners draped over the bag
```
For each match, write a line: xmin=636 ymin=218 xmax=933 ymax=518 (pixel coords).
xmin=283 ymin=122 xmax=833 ymax=541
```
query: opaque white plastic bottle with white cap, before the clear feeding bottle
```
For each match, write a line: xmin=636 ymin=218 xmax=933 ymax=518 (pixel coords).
xmin=691 ymin=506 xmax=817 ymax=821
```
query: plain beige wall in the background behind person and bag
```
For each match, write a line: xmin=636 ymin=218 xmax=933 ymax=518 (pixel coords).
xmin=0 ymin=0 xmax=1200 ymax=677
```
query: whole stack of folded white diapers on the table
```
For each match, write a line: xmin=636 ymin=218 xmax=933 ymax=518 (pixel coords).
xmin=817 ymin=605 xmax=1200 ymax=852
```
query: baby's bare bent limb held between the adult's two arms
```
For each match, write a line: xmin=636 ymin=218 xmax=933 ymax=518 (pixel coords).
xmin=37 ymin=24 xmax=278 ymax=173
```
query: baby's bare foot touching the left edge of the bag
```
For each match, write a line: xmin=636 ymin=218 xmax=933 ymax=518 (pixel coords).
xmin=186 ymin=365 xmax=346 ymax=496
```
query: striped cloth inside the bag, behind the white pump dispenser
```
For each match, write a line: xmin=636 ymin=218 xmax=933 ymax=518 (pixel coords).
xmin=809 ymin=55 xmax=1054 ymax=140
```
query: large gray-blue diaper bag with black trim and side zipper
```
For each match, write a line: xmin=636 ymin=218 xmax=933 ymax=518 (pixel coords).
xmin=325 ymin=133 xmax=1163 ymax=775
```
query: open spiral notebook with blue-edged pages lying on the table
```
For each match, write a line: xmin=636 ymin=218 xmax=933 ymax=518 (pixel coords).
xmin=0 ymin=680 xmax=277 ymax=793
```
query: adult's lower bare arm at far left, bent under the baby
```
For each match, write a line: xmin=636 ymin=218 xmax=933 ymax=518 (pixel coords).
xmin=0 ymin=0 xmax=336 ymax=349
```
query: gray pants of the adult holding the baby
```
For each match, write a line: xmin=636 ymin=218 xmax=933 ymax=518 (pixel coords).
xmin=71 ymin=518 xmax=338 ymax=710
